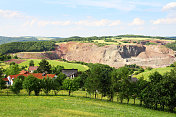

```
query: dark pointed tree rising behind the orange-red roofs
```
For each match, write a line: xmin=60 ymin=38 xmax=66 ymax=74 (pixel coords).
xmin=37 ymin=59 xmax=51 ymax=73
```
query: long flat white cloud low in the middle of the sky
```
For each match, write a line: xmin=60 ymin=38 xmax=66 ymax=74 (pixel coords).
xmin=75 ymin=19 xmax=120 ymax=26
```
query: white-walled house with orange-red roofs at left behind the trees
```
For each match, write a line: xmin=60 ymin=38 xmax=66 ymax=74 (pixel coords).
xmin=3 ymin=73 xmax=57 ymax=85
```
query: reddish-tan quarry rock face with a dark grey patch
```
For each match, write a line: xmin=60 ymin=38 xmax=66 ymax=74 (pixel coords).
xmin=56 ymin=42 xmax=175 ymax=68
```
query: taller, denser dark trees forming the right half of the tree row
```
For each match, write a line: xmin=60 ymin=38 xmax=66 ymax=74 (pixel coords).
xmin=80 ymin=64 xmax=176 ymax=112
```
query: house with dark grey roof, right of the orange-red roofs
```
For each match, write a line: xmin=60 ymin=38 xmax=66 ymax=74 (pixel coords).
xmin=62 ymin=69 xmax=78 ymax=78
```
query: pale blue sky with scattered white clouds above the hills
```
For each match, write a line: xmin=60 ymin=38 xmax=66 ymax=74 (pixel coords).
xmin=0 ymin=0 xmax=176 ymax=37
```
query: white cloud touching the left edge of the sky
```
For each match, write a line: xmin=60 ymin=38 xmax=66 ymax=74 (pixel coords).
xmin=0 ymin=9 xmax=25 ymax=18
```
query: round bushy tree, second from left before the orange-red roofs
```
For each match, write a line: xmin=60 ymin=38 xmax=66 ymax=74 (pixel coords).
xmin=23 ymin=75 xmax=42 ymax=96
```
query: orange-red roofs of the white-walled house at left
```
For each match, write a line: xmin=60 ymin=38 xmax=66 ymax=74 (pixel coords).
xmin=3 ymin=73 xmax=55 ymax=81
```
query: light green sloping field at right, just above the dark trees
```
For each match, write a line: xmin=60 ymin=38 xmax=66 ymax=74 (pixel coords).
xmin=134 ymin=67 xmax=173 ymax=80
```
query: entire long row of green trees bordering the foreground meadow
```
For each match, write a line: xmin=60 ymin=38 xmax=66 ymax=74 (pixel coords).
xmin=0 ymin=60 xmax=176 ymax=112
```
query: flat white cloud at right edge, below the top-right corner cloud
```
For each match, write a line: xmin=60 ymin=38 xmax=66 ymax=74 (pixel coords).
xmin=152 ymin=18 xmax=176 ymax=24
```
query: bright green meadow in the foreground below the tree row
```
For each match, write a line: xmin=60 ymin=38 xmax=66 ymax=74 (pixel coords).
xmin=0 ymin=91 xmax=175 ymax=117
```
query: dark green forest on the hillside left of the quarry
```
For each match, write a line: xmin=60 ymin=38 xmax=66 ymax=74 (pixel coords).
xmin=0 ymin=41 xmax=55 ymax=54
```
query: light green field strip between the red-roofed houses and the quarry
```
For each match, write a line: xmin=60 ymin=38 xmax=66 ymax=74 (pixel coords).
xmin=19 ymin=59 xmax=89 ymax=71
